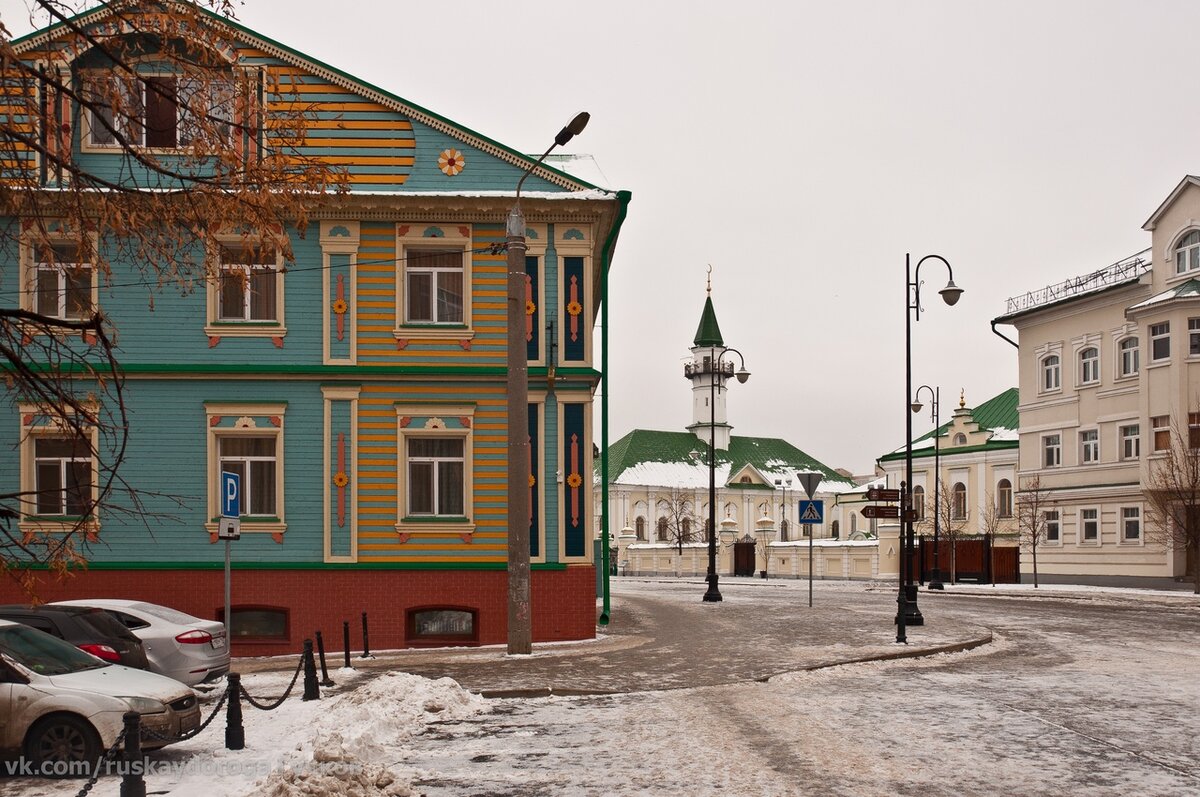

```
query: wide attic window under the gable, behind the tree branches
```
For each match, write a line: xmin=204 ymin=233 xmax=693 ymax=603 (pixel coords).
xmin=83 ymin=74 xmax=236 ymax=149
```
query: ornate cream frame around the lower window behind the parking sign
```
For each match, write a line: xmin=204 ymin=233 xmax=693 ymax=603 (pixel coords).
xmin=204 ymin=401 xmax=288 ymax=539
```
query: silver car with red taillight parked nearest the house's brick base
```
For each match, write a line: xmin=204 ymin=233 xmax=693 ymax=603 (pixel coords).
xmin=58 ymin=598 xmax=229 ymax=687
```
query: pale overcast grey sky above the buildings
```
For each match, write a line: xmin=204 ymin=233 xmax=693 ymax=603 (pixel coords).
xmin=0 ymin=0 xmax=1200 ymax=473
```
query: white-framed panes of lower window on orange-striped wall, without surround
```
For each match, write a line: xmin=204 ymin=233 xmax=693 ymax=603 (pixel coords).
xmin=404 ymin=436 xmax=468 ymax=520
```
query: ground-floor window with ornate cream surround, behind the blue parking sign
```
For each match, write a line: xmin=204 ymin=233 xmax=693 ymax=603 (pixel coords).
xmin=204 ymin=402 xmax=287 ymax=534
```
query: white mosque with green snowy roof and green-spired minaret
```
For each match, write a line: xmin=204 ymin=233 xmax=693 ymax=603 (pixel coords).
xmin=595 ymin=279 xmax=876 ymax=577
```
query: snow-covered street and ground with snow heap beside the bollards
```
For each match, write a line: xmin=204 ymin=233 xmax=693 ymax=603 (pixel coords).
xmin=0 ymin=582 xmax=1200 ymax=797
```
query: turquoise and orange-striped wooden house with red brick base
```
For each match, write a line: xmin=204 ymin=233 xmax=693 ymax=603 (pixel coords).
xmin=0 ymin=7 xmax=630 ymax=654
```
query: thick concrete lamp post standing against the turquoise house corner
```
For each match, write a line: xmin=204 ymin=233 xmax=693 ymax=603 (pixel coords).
xmin=505 ymin=112 xmax=590 ymax=655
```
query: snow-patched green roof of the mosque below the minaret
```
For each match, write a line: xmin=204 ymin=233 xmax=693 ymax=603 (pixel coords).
xmin=608 ymin=429 xmax=852 ymax=492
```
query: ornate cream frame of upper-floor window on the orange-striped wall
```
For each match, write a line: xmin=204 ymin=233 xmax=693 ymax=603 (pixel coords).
xmin=391 ymin=222 xmax=475 ymax=343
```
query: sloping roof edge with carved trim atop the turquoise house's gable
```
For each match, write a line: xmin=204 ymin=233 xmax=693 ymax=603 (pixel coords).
xmin=4 ymin=0 xmax=595 ymax=193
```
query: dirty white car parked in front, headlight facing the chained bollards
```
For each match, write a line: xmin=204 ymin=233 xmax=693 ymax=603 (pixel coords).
xmin=0 ymin=619 xmax=200 ymax=777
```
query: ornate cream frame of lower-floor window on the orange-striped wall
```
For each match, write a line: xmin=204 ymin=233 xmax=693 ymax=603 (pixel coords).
xmin=396 ymin=405 xmax=468 ymax=539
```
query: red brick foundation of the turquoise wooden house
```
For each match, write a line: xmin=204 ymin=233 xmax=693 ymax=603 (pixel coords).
xmin=0 ymin=565 xmax=595 ymax=666
